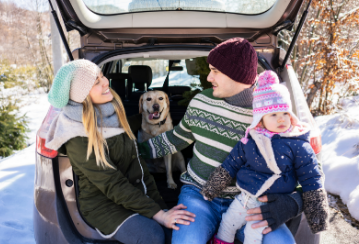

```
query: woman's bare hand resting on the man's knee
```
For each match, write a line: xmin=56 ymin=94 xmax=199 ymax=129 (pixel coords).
xmin=153 ymin=204 xmax=196 ymax=230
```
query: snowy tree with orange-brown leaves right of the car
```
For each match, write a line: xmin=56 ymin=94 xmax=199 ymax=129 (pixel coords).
xmin=279 ymin=0 xmax=359 ymax=114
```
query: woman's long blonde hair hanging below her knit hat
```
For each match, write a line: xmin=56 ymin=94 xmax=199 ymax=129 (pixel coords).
xmin=82 ymin=88 xmax=136 ymax=169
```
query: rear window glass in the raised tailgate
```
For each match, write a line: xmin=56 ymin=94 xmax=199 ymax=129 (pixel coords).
xmin=83 ymin=0 xmax=277 ymax=14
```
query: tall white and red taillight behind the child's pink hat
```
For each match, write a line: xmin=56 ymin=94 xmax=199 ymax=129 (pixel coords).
xmin=285 ymin=64 xmax=322 ymax=154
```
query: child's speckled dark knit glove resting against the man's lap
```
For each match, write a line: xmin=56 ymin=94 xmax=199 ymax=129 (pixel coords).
xmin=201 ymin=166 xmax=232 ymax=201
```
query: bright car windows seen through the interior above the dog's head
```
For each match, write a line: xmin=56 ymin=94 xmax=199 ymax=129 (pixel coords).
xmin=121 ymin=59 xmax=201 ymax=89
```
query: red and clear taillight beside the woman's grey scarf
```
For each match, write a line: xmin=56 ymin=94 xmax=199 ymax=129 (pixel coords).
xmin=36 ymin=106 xmax=61 ymax=158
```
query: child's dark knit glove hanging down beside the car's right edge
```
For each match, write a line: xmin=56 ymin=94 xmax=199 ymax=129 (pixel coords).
xmin=303 ymin=189 xmax=329 ymax=234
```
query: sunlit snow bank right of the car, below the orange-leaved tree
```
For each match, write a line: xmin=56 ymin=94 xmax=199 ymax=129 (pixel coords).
xmin=315 ymin=96 xmax=359 ymax=220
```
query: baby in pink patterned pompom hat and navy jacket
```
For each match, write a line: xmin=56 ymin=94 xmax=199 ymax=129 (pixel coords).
xmin=201 ymin=71 xmax=328 ymax=244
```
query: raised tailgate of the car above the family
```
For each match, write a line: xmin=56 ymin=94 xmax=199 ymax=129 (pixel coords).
xmin=56 ymin=0 xmax=303 ymax=59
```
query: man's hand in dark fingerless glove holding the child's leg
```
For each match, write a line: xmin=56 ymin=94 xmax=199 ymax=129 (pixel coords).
xmin=246 ymin=192 xmax=300 ymax=234
